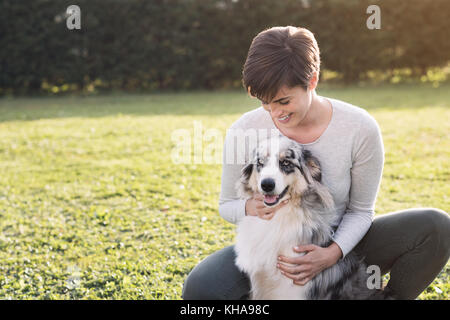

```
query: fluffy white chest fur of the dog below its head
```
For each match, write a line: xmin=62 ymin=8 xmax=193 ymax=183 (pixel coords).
xmin=235 ymin=205 xmax=310 ymax=300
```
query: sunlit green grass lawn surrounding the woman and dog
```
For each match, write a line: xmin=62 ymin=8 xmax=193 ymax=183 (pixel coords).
xmin=0 ymin=85 xmax=450 ymax=299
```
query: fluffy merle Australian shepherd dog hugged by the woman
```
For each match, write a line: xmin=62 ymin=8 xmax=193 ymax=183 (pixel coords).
xmin=234 ymin=136 xmax=393 ymax=300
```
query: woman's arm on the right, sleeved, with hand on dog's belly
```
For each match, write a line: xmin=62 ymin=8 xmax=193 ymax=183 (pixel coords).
xmin=277 ymin=117 xmax=384 ymax=285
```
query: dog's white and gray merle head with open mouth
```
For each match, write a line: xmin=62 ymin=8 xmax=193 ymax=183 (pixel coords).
xmin=238 ymin=136 xmax=322 ymax=206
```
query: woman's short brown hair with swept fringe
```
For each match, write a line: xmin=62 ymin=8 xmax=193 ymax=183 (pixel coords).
xmin=242 ymin=26 xmax=320 ymax=102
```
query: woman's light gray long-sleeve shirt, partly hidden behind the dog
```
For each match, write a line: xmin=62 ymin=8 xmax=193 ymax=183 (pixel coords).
xmin=219 ymin=98 xmax=384 ymax=256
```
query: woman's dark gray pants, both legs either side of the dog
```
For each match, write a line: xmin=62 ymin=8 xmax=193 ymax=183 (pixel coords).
xmin=182 ymin=208 xmax=450 ymax=300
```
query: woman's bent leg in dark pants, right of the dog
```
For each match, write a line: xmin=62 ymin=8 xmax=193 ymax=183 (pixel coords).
xmin=354 ymin=208 xmax=450 ymax=299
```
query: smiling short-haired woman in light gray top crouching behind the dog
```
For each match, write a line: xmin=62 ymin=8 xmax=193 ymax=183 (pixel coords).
xmin=183 ymin=27 xmax=450 ymax=299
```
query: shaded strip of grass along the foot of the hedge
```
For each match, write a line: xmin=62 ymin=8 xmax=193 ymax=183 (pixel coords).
xmin=0 ymin=83 xmax=450 ymax=122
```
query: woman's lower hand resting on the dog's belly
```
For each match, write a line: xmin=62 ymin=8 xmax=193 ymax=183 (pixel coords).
xmin=277 ymin=242 xmax=342 ymax=286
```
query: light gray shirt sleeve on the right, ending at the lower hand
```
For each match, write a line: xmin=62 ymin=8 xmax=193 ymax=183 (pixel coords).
xmin=333 ymin=115 xmax=384 ymax=257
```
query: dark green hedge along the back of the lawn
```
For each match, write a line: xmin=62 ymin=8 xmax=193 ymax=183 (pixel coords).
xmin=0 ymin=0 xmax=450 ymax=95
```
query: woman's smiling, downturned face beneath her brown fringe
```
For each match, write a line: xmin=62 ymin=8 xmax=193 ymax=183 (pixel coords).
xmin=261 ymin=86 xmax=312 ymax=129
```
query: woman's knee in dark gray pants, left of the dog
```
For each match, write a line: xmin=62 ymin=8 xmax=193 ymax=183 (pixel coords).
xmin=181 ymin=246 xmax=250 ymax=300
